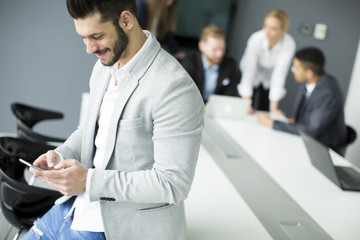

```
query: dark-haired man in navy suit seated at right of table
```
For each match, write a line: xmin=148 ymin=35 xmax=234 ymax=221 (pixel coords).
xmin=258 ymin=48 xmax=347 ymax=151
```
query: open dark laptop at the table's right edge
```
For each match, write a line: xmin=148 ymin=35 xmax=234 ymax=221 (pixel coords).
xmin=299 ymin=130 xmax=360 ymax=191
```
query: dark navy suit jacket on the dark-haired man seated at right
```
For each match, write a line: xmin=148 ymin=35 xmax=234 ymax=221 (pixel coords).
xmin=274 ymin=74 xmax=346 ymax=149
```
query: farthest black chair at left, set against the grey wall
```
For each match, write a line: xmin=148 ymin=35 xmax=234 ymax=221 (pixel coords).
xmin=11 ymin=103 xmax=65 ymax=144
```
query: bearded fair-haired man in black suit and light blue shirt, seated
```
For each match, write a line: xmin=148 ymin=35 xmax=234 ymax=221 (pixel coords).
xmin=181 ymin=24 xmax=240 ymax=103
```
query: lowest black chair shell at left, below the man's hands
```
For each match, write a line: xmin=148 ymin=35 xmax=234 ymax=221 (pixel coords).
xmin=0 ymin=169 xmax=61 ymax=229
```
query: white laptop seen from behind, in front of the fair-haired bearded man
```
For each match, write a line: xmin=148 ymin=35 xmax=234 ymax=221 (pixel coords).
xmin=205 ymin=94 xmax=251 ymax=120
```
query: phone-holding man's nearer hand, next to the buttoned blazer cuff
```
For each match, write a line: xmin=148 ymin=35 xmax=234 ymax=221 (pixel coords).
xmin=30 ymin=156 xmax=88 ymax=196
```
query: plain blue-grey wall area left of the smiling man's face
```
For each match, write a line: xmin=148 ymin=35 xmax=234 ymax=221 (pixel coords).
xmin=0 ymin=0 xmax=96 ymax=137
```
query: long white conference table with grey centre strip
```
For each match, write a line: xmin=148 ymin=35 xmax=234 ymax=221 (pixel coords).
xmin=185 ymin=116 xmax=360 ymax=240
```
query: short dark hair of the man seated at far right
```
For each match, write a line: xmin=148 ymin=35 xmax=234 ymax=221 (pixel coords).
xmin=295 ymin=47 xmax=325 ymax=75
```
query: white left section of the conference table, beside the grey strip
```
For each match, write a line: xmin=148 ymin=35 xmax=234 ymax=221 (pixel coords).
xmin=185 ymin=146 xmax=272 ymax=240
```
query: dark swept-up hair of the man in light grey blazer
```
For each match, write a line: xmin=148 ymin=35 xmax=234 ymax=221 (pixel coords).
xmin=66 ymin=0 xmax=137 ymax=24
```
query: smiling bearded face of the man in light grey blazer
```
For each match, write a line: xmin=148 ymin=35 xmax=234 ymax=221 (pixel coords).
xmin=74 ymin=13 xmax=129 ymax=66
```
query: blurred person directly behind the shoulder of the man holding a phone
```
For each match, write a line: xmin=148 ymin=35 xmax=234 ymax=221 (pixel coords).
xmin=136 ymin=0 xmax=185 ymax=59
